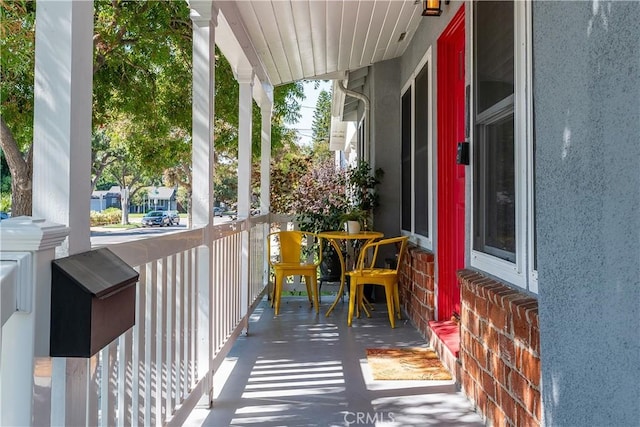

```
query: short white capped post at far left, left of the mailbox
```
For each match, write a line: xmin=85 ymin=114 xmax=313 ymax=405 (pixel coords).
xmin=0 ymin=217 xmax=69 ymax=426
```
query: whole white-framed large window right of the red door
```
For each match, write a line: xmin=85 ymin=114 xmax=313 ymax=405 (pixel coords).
xmin=471 ymin=1 xmax=537 ymax=292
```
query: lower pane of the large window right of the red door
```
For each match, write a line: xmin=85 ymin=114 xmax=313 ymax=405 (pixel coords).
xmin=474 ymin=114 xmax=516 ymax=262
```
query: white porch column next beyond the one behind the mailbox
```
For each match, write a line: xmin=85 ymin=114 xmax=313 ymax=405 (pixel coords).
xmin=191 ymin=2 xmax=217 ymax=406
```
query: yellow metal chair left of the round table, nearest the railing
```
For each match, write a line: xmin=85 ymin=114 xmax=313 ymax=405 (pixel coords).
xmin=267 ymin=231 xmax=322 ymax=315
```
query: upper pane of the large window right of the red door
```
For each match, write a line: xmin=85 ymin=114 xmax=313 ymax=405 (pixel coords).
xmin=475 ymin=1 xmax=514 ymax=114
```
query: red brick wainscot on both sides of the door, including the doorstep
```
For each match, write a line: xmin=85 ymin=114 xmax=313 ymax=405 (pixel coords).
xmin=400 ymin=246 xmax=542 ymax=426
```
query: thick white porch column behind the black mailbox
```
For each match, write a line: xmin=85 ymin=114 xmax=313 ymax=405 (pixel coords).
xmin=33 ymin=0 xmax=97 ymax=425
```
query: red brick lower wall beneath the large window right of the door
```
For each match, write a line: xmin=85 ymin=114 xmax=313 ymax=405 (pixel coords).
xmin=458 ymin=270 xmax=542 ymax=426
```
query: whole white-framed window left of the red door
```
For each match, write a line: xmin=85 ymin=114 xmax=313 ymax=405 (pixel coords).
xmin=401 ymin=49 xmax=433 ymax=249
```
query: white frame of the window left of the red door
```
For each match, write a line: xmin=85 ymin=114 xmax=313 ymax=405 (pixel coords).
xmin=400 ymin=46 xmax=436 ymax=250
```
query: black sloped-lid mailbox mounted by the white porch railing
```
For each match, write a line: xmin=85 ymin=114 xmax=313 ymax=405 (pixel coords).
xmin=49 ymin=248 xmax=139 ymax=357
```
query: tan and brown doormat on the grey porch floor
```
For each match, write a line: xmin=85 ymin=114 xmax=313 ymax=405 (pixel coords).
xmin=367 ymin=348 xmax=451 ymax=380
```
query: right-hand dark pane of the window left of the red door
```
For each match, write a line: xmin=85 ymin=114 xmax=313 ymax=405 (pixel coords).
xmin=415 ymin=64 xmax=429 ymax=237
